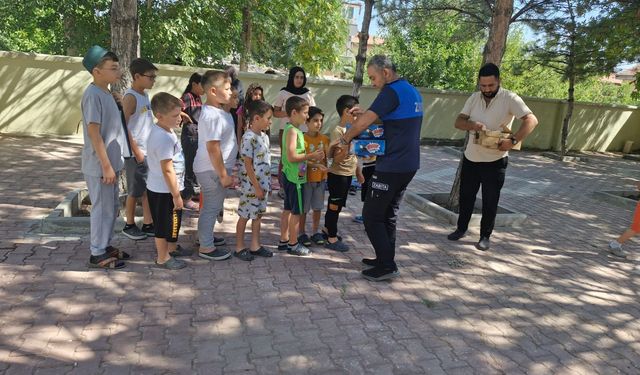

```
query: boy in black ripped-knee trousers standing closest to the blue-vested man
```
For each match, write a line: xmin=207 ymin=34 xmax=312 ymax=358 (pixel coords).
xmin=324 ymin=95 xmax=364 ymax=252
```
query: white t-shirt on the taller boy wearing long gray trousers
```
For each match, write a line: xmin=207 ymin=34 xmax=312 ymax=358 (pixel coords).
xmin=193 ymin=104 xmax=238 ymax=173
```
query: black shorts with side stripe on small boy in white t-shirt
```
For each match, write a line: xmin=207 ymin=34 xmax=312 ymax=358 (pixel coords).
xmin=147 ymin=189 xmax=182 ymax=242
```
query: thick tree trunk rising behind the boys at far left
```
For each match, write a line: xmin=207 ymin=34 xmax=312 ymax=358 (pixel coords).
xmin=111 ymin=0 xmax=140 ymax=94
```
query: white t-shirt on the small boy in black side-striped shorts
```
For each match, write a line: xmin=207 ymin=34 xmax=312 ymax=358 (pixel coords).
xmin=147 ymin=125 xmax=185 ymax=193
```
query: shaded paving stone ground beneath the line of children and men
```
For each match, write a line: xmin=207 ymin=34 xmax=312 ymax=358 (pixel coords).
xmin=0 ymin=136 xmax=640 ymax=374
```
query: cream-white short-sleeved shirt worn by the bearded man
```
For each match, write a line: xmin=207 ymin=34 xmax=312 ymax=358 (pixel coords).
xmin=460 ymin=88 xmax=532 ymax=162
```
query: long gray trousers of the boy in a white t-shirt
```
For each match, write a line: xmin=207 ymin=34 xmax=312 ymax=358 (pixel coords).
xmin=196 ymin=170 xmax=231 ymax=249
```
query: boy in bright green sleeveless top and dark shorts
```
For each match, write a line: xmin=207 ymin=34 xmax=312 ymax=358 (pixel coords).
xmin=278 ymin=96 xmax=325 ymax=256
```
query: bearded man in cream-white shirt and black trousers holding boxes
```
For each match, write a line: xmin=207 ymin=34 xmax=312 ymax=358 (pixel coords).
xmin=447 ymin=63 xmax=538 ymax=251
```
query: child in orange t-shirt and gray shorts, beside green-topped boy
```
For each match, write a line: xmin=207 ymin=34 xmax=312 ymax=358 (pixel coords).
xmin=298 ymin=107 xmax=329 ymax=246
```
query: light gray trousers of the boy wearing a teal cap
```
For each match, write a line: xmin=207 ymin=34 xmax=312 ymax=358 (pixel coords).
xmin=84 ymin=172 xmax=120 ymax=256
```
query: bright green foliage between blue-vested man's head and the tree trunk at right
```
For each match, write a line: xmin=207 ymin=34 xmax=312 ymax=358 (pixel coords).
xmin=383 ymin=16 xmax=482 ymax=91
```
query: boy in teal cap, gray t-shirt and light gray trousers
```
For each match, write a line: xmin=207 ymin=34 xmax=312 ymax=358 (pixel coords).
xmin=81 ymin=46 xmax=130 ymax=268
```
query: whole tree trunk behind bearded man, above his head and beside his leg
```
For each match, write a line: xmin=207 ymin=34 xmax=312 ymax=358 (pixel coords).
xmin=447 ymin=0 xmax=513 ymax=212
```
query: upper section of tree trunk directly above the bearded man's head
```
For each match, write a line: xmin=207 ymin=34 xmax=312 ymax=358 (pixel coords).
xmin=482 ymin=0 xmax=513 ymax=66
